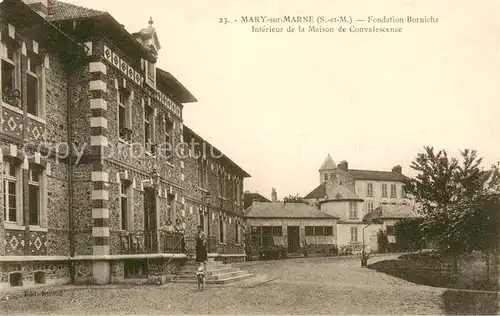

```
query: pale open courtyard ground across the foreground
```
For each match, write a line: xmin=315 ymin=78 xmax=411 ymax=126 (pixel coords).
xmin=0 ymin=257 xmax=498 ymax=315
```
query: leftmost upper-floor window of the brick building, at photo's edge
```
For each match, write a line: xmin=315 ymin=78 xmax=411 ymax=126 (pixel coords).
xmin=2 ymin=47 xmax=21 ymax=106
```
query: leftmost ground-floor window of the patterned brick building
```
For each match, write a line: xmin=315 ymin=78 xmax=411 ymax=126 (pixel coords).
xmin=3 ymin=161 xmax=22 ymax=222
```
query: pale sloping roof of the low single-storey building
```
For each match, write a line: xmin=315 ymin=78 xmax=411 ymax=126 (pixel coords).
xmin=245 ymin=202 xmax=337 ymax=219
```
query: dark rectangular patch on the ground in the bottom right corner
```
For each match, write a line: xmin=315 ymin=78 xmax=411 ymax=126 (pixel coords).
xmin=441 ymin=290 xmax=499 ymax=315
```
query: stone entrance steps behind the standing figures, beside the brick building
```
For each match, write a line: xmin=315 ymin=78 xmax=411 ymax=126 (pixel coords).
xmin=171 ymin=261 xmax=253 ymax=284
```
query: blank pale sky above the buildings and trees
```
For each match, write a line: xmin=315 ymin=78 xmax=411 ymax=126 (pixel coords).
xmin=66 ymin=0 xmax=500 ymax=198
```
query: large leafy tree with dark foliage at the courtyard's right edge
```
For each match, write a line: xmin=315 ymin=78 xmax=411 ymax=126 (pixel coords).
xmin=405 ymin=147 xmax=500 ymax=271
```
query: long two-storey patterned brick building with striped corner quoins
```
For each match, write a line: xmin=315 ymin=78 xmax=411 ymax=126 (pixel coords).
xmin=0 ymin=0 xmax=249 ymax=288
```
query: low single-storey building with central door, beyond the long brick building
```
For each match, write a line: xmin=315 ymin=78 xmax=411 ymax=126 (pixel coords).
xmin=245 ymin=202 xmax=338 ymax=253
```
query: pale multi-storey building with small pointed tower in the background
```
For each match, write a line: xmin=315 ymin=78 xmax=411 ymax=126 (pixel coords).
xmin=304 ymin=155 xmax=415 ymax=251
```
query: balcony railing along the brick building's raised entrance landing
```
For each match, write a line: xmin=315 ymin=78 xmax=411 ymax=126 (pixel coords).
xmin=120 ymin=230 xmax=184 ymax=254
